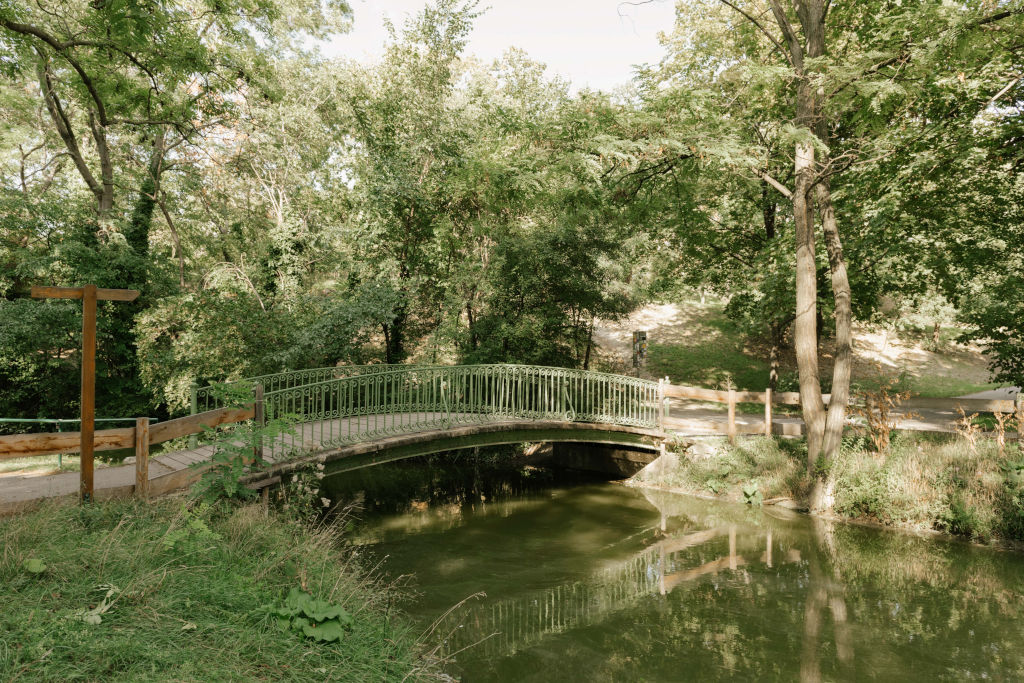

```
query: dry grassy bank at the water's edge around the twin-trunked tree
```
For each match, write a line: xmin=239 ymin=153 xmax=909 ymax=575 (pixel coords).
xmin=649 ymin=432 xmax=1024 ymax=542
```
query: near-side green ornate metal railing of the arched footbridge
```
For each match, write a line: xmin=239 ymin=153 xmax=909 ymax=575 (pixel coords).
xmin=251 ymin=365 xmax=660 ymax=459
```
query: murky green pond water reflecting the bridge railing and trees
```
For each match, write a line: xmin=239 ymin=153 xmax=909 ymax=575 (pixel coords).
xmin=323 ymin=462 xmax=1024 ymax=681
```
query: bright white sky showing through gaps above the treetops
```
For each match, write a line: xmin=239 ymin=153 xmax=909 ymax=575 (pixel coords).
xmin=324 ymin=0 xmax=675 ymax=90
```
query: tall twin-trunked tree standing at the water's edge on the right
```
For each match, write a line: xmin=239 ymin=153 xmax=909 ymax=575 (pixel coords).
xmin=652 ymin=0 xmax=1018 ymax=505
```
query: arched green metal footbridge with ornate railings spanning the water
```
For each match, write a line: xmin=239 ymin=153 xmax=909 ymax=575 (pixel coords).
xmin=191 ymin=365 xmax=665 ymax=469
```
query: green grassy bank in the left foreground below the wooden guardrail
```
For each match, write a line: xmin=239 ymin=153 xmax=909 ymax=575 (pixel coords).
xmin=0 ymin=499 xmax=425 ymax=681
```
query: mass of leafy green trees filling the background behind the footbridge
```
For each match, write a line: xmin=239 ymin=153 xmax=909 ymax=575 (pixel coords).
xmin=0 ymin=0 xmax=1024 ymax=475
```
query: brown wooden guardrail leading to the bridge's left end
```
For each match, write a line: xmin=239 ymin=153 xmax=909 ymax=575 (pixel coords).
xmin=0 ymin=403 xmax=254 ymax=498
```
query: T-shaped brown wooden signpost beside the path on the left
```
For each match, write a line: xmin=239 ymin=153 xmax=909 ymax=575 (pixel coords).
xmin=32 ymin=285 xmax=138 ymax=503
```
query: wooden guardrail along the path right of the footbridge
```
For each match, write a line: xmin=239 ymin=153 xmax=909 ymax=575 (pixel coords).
xmin=662 ymin=381 xmax=1021 ymax=442
